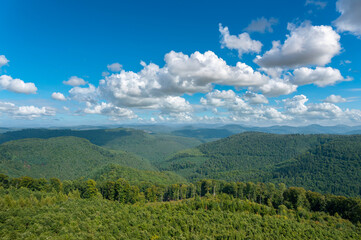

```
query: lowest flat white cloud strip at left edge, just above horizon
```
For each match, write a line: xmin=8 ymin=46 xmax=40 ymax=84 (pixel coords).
xmin=0 ymin=102 xmax=56 ymax=120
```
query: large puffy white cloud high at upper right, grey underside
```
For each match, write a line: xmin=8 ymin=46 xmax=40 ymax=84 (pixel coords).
xmin=254 ymin=22 xmax=341 ymax=68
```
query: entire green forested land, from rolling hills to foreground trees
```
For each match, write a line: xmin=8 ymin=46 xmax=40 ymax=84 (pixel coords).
xmin=0 ymin=128 xmax=361 ymax=239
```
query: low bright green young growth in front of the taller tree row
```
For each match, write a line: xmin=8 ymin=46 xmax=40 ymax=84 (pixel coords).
xmin=0 ymin=189 xmax=361 ymax=239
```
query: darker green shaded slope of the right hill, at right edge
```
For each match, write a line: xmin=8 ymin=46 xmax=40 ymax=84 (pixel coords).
xmin=273 ymin=135 xmax=361 ymax=196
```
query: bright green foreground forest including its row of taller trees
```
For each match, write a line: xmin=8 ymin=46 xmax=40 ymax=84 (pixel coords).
xmin=0 ymin=174 xmax=361 ymax=239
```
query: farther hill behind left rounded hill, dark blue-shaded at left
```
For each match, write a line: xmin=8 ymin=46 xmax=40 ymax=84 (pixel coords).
xmin=0 ymin=128 xmax=202 ymax=161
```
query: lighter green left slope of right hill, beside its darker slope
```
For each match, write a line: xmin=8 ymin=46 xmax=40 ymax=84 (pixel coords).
xmin=160 ymin=132 xmax=326 ymax=180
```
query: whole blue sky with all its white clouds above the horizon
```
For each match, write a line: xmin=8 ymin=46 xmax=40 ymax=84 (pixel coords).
xmin=0 ymin=0 xmax=361 ymax=127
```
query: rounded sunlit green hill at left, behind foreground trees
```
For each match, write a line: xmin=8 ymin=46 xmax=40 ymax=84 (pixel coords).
xmin=0 ymin=137 xmax=155 ymax=179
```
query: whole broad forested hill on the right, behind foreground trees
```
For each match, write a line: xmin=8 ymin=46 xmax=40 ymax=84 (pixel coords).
xmin=159 ymin=132 xmax=361 ymax=196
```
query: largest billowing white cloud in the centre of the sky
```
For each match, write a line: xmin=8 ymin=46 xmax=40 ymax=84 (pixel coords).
xmin=99 ymin=51 xmax=268 ymax=108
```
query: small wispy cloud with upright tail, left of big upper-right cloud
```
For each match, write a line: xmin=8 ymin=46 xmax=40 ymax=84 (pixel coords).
xmin=219 ymin=24 xmax=263 ymax=57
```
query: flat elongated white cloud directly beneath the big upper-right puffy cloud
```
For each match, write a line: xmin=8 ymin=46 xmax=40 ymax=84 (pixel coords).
xmin=292 ymin=67 xmax=352 ymax=87
